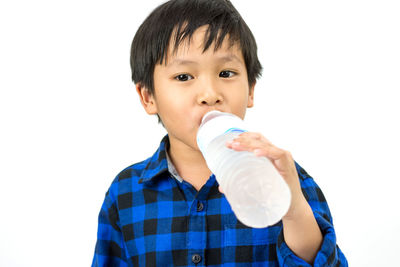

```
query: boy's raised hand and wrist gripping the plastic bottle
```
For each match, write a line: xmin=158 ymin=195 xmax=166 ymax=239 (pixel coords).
xmin=226 ymin=132 xmax=309 ymax=220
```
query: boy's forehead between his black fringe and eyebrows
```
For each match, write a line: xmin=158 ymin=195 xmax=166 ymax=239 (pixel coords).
xmin=165 ymin=25 xmax=244 ymax=65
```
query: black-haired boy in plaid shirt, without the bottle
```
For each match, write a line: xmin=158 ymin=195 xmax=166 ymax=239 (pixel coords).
xmin=92 ymin=0 xmax=347 ymax=266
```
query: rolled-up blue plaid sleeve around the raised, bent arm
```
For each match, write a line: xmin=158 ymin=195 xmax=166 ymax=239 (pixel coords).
xmin=277 ymin=162 xmax=348 ymax=267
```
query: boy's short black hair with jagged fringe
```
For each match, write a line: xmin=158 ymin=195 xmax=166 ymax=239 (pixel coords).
xmin=130 ymin=0 xmax=262 ymax=127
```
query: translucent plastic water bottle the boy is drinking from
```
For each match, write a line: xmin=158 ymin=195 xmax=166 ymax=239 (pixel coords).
xmin=197 ymin=110 xmax=291 ymax=228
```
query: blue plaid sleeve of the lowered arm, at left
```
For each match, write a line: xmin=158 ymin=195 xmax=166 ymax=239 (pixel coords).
xmin=92 ymin=183 xmax=128 ymax=267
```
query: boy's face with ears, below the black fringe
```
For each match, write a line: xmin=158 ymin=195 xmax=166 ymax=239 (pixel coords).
xmin=137 ymin=26 xmax=254 ymax=155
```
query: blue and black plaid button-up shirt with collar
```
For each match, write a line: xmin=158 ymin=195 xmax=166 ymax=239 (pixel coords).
xmin=92 ymin=135 xmax=347 ymax=266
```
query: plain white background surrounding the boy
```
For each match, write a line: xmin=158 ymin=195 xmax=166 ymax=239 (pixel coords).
xmin=0 ymin=0 xmax=400 ymax=266
